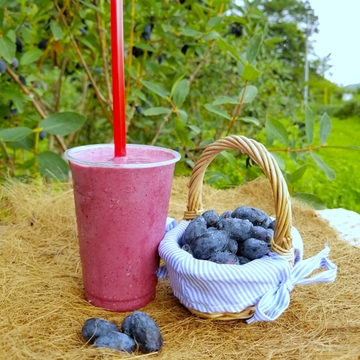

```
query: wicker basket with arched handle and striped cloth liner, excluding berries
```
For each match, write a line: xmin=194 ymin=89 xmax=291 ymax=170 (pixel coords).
xmin=158 ymin=136 xmax=337 ymax=323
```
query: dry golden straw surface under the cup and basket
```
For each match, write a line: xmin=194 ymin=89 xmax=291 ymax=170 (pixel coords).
xmin=0 ymin=178 xmax=360 ymax=360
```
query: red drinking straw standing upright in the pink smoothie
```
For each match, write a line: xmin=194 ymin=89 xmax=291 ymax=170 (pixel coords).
xmin=110 ymin=0 xmax=126 ymax=157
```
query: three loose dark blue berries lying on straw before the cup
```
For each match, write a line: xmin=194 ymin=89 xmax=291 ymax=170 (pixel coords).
xmin=81 ymin=311 xmax=164 ymax=354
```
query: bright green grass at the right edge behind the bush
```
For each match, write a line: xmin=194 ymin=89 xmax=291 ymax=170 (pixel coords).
xmin=296 ymin=118 xmax=360 ymax=213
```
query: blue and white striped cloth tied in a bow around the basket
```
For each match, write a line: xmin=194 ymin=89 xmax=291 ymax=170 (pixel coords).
xmin=157 ymin=220 xmax=337 ymax=323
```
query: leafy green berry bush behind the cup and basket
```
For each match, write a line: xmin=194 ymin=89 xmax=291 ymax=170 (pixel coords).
xmin=0 ymin=0 xmax=358 ymax=210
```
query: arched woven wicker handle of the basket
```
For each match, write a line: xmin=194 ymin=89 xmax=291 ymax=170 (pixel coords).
xmin=184 ymin=135 xmax=293 ymax=261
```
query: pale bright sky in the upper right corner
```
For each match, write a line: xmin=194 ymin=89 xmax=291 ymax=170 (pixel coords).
xmin=309 ymin=0 xmax=360 ymax=86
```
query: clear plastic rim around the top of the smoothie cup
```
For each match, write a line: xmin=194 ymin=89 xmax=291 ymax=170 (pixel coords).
xmin=64 ymin=144 xmax=181 ymax=169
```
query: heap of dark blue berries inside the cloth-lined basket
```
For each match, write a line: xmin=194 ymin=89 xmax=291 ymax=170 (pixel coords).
xmin=180 ymin=206 xmax=275 ymax=265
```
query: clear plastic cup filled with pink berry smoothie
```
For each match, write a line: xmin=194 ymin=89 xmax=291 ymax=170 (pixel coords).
xmin=65 ymin=144 xmax=180 ymax=311
